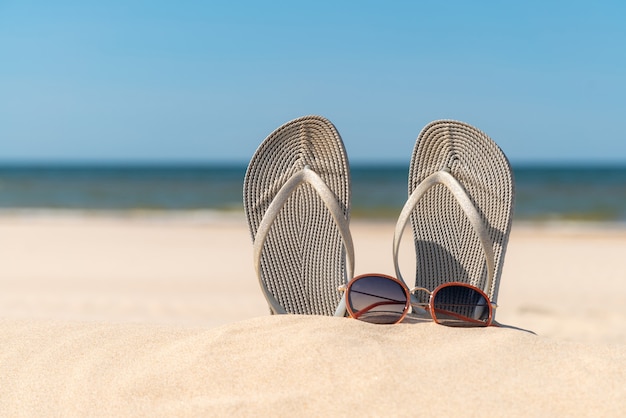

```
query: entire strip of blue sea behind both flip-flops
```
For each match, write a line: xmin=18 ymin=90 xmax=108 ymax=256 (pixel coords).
xmin=0 ymin=164 xmax=626 ymax=224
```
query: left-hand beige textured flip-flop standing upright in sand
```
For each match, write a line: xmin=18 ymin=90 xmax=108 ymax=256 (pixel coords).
xmin=243 ymin=116 xmax=354 ymax=316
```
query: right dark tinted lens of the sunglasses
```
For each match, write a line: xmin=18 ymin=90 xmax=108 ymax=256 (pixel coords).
xmin=431 ymin=285 xmax=489 ymax=327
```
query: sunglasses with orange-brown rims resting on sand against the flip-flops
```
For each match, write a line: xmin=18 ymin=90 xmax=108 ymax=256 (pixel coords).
xmin=339 ymin=274 xmax=497 ymax=327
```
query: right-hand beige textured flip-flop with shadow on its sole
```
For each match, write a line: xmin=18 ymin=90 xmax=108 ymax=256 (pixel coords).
xmin=393 ymin=120 xmax=515 ymax=302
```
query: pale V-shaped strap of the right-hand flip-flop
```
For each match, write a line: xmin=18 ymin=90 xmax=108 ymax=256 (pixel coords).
xmin=393 ymin=170 xmax=495 ymax=294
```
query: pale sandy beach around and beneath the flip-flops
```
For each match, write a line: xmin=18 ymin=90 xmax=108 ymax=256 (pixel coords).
xmin=0 ymin=212 xmax=626 ymax=417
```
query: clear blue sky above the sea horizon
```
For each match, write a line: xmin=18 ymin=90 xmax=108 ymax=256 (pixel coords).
xmin=0 ymin=0 xmax=626 ymax=164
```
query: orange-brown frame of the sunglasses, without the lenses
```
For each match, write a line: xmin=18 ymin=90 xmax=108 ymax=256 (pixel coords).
xmin=337 ymin=273 xmax=498 ymax=327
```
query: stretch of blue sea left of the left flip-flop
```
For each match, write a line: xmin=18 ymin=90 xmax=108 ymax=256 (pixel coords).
xmin=0 ymin=165 xmax=245 ymax=210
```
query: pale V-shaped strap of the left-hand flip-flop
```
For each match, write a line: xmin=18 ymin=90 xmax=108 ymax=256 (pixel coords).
xmin=253 ymin=166 xmax=354 ymax=316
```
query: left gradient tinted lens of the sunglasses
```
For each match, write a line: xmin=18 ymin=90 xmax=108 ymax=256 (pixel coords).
xmin=348 ymin=276 xmax=407 ymax=324
